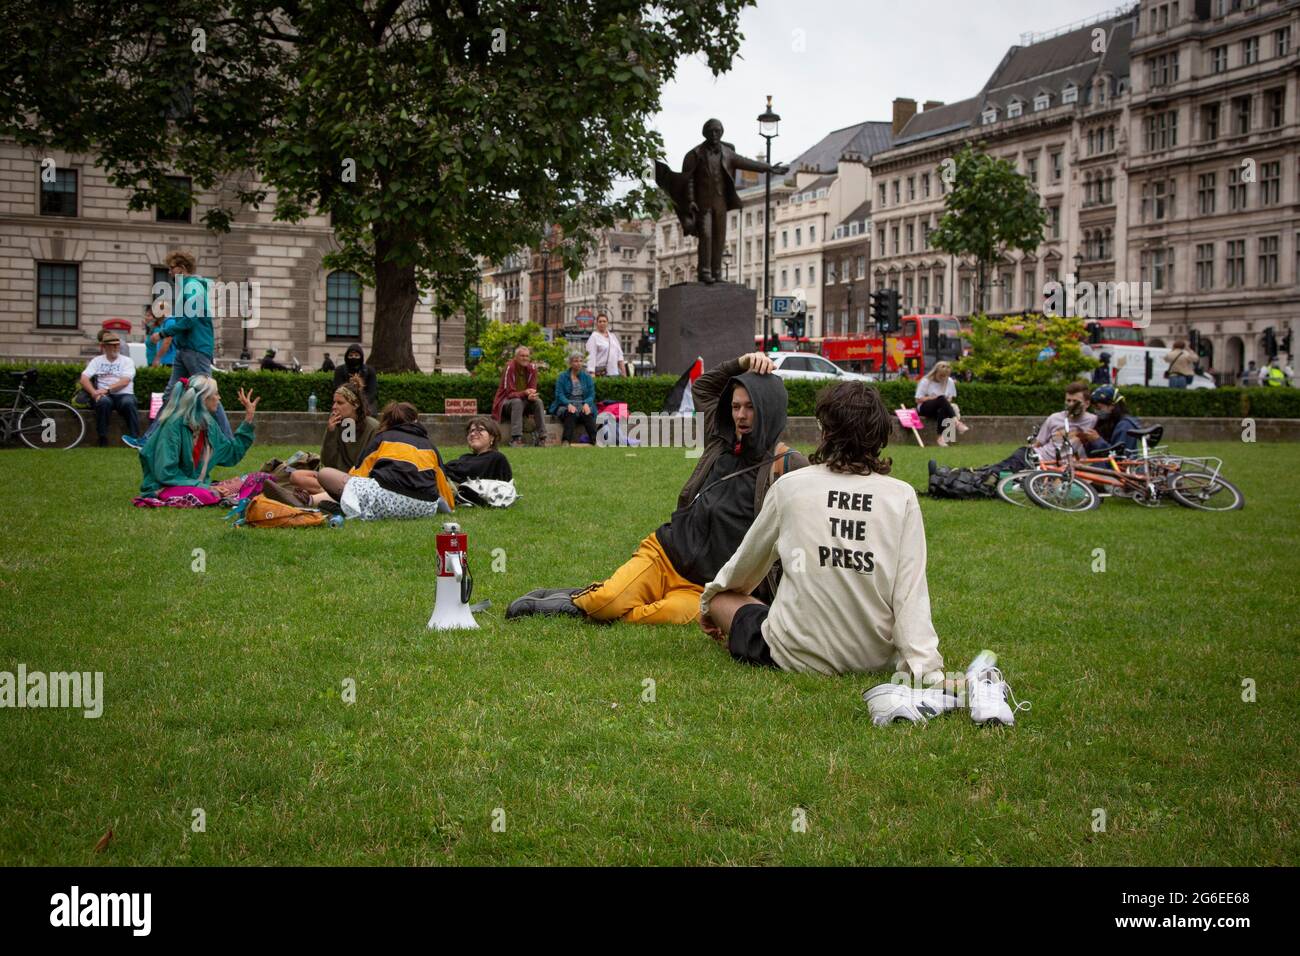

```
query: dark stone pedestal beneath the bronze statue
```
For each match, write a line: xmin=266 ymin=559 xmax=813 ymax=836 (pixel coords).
xmin=655 ymin=282 xmax=762 ymax=375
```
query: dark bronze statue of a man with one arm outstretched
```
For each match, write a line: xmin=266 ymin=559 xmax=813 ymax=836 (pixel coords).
xmin=654 ymin=120 xmax=790 ymax=284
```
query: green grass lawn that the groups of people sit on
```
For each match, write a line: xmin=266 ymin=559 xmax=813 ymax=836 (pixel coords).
xmin=0 ymin=445 xmax=1300 ymax=865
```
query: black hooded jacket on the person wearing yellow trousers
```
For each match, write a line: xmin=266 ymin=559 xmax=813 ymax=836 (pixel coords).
xmin=655 ymin=372 xmax=802 ymax=587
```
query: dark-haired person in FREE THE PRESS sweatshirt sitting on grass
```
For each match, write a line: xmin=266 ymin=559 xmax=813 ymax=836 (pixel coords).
xmin=698 ymin=381 xmax=1014 ymax=723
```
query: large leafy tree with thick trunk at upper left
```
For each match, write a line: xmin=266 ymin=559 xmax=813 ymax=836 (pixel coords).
xmin=0 ymin=0 xmax=753 ymax=371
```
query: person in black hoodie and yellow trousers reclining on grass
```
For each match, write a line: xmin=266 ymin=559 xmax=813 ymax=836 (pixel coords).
xmin=506 ymin=352 xmax=807 ymax=624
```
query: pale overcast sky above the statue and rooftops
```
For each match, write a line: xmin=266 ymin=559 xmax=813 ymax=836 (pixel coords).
xmin=639 ymin=0 xmax=1114 ymax=169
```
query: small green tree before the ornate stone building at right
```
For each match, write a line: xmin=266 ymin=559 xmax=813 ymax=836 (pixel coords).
xmin=930 ymin=146 xmax=1048 ymax=312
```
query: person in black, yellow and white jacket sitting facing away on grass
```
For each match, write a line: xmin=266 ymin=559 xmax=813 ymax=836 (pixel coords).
xmin=313 ymin=402 xmax=455 ymax=522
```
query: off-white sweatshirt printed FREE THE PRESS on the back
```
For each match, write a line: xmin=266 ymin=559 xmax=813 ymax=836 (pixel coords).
xmin=699 ymin=464 xmax=944 ymax=679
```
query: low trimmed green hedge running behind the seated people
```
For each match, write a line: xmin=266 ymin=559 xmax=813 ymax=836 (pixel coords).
xmin=10 ymin=364 xmax=1300 ymax=419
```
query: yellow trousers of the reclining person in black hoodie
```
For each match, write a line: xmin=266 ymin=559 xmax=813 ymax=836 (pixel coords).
xmin=573 ymin=533 xmax=705 ymax=624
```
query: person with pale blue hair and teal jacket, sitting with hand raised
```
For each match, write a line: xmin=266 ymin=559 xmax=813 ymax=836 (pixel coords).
xmin=140 ymin=375 xmax=261 ymax=505
